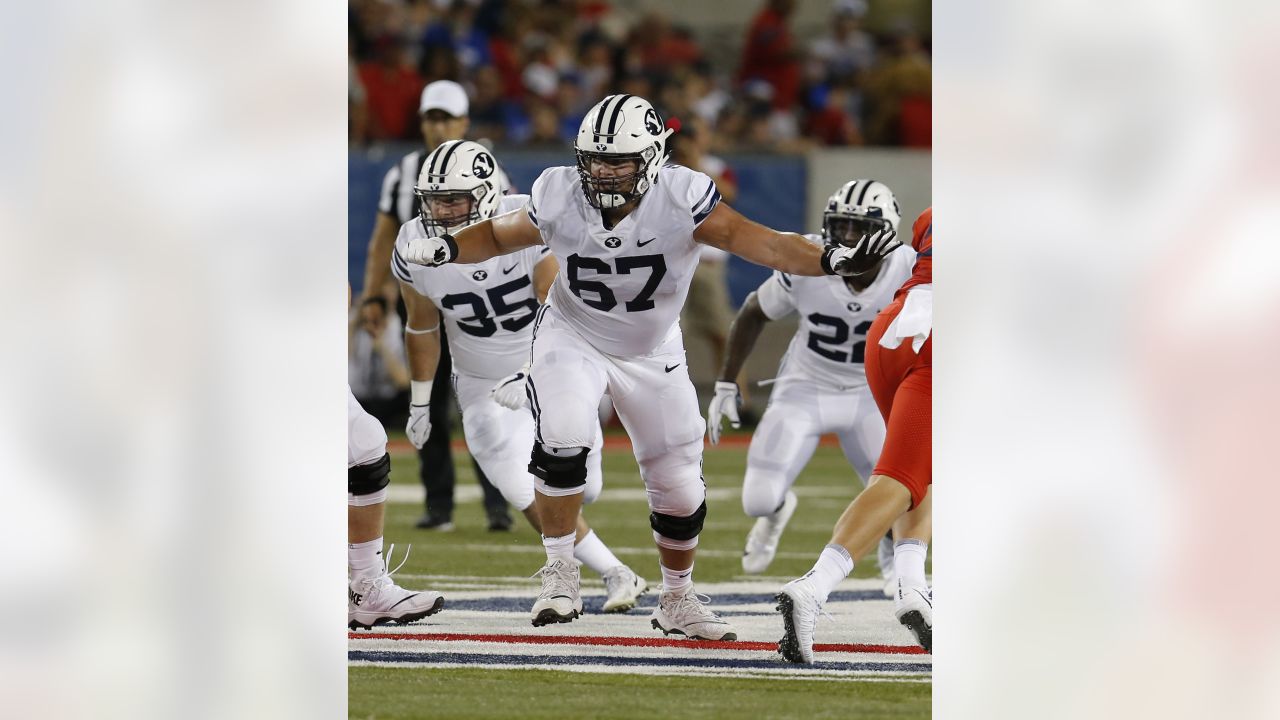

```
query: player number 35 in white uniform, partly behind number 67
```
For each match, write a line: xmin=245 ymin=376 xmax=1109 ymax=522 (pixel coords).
xmin=392 ymin=140 xmax=648 ymax=612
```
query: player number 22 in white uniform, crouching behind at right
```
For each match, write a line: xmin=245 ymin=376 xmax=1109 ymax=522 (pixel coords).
xmin=707 ymin=179 xmax=915 ymax=592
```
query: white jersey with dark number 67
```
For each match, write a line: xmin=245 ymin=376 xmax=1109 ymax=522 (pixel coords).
xmin=529 ymin=165 xmax=719 ymax=357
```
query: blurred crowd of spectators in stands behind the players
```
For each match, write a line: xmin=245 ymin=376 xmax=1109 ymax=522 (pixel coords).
xmin=348 ymin=0 xmax=932 ymax=152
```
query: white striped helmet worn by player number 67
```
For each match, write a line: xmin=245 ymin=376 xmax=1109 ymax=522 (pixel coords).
xmin=573 ymin=95 xmax=673 ymax=208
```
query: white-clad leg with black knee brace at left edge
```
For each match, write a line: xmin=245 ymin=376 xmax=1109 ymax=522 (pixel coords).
xmin=347 ymin=288 xmax=444 ymax=630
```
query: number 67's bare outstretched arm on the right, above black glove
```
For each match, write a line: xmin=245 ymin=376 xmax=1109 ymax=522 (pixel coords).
xmin=694 ymin=202 xmax=824 ymax=275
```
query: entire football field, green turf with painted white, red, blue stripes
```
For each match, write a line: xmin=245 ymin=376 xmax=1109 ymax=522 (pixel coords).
xmin=348 ymin=434 xmax=932 ymax=719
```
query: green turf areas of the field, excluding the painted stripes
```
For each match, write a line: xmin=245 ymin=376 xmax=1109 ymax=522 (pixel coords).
xmin=358 ymin=427 xmax=932 ymax=720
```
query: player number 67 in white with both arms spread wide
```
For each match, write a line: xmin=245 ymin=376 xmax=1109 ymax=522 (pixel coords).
xmin=397 ymin=95 xmax=899 ymax=639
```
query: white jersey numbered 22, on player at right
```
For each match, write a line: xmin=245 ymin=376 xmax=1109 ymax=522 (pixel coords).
xmin=755 ymin=234 xmax=915 ymax=388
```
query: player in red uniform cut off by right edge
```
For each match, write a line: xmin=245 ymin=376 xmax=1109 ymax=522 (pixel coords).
xmin=777 ymin=208 xmax=933 ymax=662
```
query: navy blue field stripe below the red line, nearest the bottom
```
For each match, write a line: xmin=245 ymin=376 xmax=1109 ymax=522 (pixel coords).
xmin=347 ymin=650 xmax=933 ymax=673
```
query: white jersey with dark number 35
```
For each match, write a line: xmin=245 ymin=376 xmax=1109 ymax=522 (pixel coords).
xmin=392 ymin=195 xmax=548 ymax=379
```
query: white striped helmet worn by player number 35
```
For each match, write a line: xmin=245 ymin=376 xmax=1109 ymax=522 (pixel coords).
xmin=413 ymin=140 xmax=502 ymax=236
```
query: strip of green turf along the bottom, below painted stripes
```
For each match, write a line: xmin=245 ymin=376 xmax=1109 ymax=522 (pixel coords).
xmin=347 ymin=667 xmax=932 ymax=720
